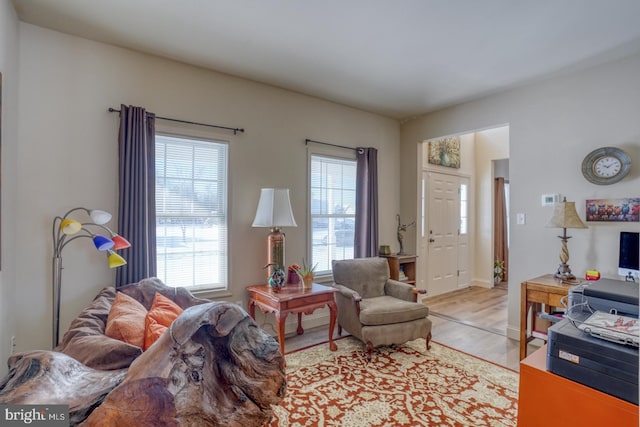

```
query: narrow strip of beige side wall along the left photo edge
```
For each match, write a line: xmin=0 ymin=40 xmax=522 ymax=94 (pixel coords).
xmin=0 ymin=0 xmax=18 ymax=376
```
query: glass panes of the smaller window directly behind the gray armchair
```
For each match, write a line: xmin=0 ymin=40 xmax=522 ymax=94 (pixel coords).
xmin=309 ymin=154 xmax=356 ymax=274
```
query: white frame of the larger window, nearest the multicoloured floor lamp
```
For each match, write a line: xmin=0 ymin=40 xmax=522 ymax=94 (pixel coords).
xmin=154 ymin=128 xmax=231 ymax=298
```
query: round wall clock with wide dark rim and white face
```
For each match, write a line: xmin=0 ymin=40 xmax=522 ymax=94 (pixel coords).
xmin=582 ymin=147 xmax=631 ymax=185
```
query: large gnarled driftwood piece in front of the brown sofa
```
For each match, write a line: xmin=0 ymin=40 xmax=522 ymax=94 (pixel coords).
xmin=0 ymin=280 xmax=286 ymax=427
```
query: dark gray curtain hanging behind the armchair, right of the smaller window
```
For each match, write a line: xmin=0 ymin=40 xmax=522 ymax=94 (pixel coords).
xmin=354 ymin=148 xmax=378 ymax=258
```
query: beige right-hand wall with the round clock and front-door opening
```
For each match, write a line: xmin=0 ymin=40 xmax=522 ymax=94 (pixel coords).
xmin=400 ymin=55 xmax=640 ymax=338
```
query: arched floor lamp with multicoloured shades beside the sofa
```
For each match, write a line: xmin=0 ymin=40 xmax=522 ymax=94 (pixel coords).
xmin=52 ymin=208 xmax=131 ymax=348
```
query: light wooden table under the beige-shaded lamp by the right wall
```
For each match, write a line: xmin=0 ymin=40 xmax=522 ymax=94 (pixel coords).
xmin=520 ymin=274 xmax=578 ymax=360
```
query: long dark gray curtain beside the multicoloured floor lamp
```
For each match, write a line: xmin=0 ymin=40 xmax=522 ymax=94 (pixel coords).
xmin=116 ymin=105 xmax=156 ymax=287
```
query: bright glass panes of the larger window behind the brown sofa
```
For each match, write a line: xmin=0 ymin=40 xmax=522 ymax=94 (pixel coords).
xmin=156 ymin=135 xmax=228 ymax=290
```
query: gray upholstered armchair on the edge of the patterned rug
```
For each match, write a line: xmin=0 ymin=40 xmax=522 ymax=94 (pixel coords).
xmin=333 ymin=258 xmax=431 ymax=358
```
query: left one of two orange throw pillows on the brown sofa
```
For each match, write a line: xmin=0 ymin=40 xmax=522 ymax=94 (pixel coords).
xmin=104 ymin=292 xmax=147 ymax=347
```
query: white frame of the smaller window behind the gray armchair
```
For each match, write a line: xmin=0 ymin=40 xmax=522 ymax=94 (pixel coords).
xmin=306 ymin=146 xmax=357 ymax=282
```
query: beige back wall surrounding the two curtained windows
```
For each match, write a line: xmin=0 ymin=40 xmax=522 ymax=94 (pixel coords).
xmin=12 ymin=23 xmax=400 ymax=349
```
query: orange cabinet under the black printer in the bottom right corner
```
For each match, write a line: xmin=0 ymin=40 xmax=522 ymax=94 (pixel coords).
xmin=518 ymin=345 xmax=638 ymax=427
